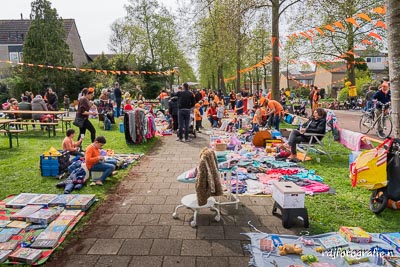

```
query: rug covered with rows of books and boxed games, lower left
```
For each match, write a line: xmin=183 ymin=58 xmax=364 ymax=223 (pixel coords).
xmin=0 ymin=193 xmax=96 ymax=265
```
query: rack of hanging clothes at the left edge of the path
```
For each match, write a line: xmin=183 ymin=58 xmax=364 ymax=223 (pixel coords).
xmin=124 ymin=108 xmax=156 ymax=144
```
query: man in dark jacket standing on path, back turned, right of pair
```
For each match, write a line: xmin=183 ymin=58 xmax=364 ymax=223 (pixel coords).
xmin=177 ymin=83 xmax=196 ymax=142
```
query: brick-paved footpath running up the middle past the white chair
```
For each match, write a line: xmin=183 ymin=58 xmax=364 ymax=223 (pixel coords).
xmin=46 ymin=134 xmax=301 ymax=267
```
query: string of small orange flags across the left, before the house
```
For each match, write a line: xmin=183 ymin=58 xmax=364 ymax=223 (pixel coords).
xmin=0 ymin=60 xmax=176 ymax=76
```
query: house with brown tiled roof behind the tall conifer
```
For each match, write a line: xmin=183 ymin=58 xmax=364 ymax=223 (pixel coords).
xmin=0 ymin=19 xmax=91 ymax=68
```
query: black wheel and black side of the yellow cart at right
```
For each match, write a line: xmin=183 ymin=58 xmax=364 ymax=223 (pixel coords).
xmin=369 ymin=139 xmax=400 ymax=214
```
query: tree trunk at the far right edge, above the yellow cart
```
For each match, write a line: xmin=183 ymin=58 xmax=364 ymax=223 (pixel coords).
xmin=386 ymin=0 xmax=400 ymax=138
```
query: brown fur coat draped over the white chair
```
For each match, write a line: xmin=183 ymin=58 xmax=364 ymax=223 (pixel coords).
xmin=196 ymin=148 xmax=223 ymax=206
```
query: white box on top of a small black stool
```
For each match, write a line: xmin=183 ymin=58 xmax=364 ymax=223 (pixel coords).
xmin=272 ymin=182 xmax=305 ymax=209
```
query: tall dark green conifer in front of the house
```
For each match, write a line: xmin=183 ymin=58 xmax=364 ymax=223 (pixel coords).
xmin=21 ymin=0 xmax=72 ymax=94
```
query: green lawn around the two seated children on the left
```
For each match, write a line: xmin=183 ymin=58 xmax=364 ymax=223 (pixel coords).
xmin=0 ymin=119 xmax=158 ymax=203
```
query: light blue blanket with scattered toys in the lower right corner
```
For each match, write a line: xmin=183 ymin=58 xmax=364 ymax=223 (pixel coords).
xmin=244 ymin=227 xmax=400 ymax=267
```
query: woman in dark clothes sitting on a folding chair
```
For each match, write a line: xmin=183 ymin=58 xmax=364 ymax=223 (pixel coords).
xmin=288 ymin=108 xmax=326 ymax=162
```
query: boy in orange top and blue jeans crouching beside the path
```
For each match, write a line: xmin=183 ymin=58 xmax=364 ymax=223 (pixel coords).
xmin=85 ymin=136 xmax=116 ymax=185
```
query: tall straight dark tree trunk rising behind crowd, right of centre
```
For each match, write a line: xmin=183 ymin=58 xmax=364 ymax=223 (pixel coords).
xmin=271 ymin=0 xmax=280 ymax=100
